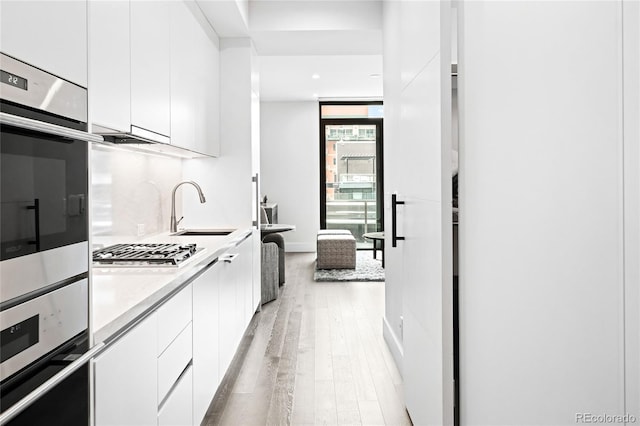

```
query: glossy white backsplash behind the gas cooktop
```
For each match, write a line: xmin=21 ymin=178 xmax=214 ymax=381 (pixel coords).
xmin=90 ymin=144 xmax=182 ymax=241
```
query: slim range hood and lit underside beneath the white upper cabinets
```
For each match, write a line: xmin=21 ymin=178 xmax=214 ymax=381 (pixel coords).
xmin=92 ymin=124 xmax=208 ymax=158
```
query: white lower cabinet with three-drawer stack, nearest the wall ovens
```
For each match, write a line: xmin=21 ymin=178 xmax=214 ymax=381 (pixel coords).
xmin=93 ymin=284 xmax=193 ymax=426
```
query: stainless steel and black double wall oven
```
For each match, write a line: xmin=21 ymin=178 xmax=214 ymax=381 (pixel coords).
xmin=0 ymin=54 xmax=102 ymax=425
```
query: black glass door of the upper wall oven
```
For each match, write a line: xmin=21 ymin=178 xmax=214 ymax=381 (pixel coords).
xmin=0 ymin=126 xmax=88 ymax=260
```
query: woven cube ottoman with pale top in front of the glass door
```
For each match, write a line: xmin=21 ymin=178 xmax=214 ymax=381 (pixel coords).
xmin=316 ymin=231 xmax=356 ymax=269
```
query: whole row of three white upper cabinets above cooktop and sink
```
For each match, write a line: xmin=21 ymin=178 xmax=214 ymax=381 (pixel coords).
xmin=89 ymin=0 xmax=220 ymax=156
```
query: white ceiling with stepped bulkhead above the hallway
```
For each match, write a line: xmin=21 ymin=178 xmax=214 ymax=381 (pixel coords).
xmin=198 ymin=0 xmax=382 ymax=101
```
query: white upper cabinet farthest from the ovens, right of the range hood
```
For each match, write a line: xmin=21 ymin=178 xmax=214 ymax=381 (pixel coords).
xmin=171 ymin=1 xmax=220 ymax=156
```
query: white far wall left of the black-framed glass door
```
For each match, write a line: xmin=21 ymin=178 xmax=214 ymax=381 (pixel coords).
xmin=260 ymin=102 xmax=320 ymax=252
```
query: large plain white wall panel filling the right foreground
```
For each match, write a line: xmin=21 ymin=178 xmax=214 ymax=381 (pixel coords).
xmin=458 ymin=2 xmax=637 ymax=425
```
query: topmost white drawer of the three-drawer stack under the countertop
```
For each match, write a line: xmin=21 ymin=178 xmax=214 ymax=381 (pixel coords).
xmin=158 ymin=284 xmax=192 ymax=355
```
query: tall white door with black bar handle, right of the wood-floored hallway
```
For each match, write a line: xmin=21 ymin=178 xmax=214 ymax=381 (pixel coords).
xmin=385 ymin=2 xmax=453 ymax=425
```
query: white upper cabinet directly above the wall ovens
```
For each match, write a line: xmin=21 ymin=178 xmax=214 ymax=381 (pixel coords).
xmin=0 ymin=1 xmax=87 ymax=87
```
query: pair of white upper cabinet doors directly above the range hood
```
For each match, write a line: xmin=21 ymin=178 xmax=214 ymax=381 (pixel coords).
xmin=89 ymin=0 xmax=171 ymax=142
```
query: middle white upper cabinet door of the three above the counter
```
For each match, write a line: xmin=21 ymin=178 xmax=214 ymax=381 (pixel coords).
xmin=130 ymin=1 xmax=171 ymax=136
